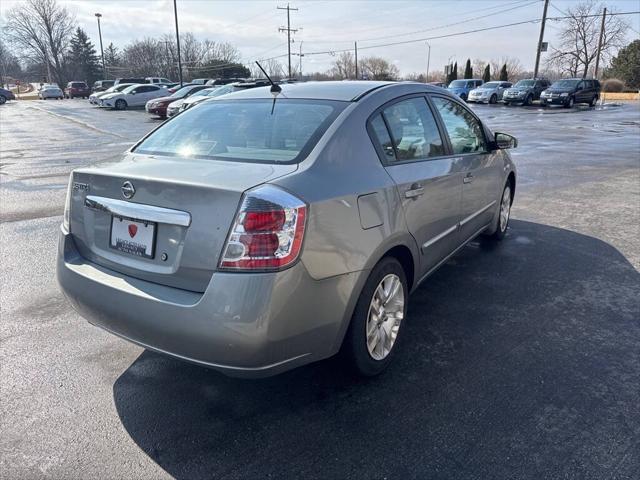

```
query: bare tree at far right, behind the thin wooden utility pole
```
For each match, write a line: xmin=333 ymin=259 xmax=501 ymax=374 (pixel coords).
xmin=547 ymin=1 xmax=628 ymax=78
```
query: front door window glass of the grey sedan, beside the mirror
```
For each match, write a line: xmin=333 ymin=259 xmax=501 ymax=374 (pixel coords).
xmin=433 ymin=97 xmax=486 ymax=155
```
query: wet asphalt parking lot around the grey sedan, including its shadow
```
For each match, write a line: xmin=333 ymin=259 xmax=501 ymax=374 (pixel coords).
xmin=0 ymin=100 xmax=640 ymax=480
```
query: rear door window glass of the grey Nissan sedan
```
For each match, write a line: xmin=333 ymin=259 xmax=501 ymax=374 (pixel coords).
xmin=382 ymin=97 xmax=444 ymax=162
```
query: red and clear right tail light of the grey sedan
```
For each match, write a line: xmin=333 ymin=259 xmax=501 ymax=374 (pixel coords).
xmin=219 ymin=185 xmax=307 ymax=271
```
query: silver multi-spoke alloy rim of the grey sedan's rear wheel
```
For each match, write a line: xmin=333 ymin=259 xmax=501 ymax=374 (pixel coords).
xmin=366 ymin=273 xmax=405 ymax=360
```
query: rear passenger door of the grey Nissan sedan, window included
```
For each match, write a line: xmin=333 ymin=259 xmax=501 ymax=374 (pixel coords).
xmin=368 ymin=95 xmax=462 ymax=276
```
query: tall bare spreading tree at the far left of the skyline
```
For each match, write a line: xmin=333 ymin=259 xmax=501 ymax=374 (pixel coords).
xmin=4 ymin=0 xmax=75 ymax=86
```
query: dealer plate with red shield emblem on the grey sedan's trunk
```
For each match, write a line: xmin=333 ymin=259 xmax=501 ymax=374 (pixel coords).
xmin=109 ymin=215 xmax=158 ymax=259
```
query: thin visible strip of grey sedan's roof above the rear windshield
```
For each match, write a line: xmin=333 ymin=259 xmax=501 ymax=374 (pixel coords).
xmin=215 ymin=80 xmax=404 ymax=102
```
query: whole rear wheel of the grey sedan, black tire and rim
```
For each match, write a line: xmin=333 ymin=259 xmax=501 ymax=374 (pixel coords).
xmin=341 ymin=257 xmax=409 ymax=377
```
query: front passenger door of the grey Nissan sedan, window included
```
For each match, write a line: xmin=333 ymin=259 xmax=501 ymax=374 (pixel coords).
xmin=431 ymin=95 xmax=501 ymax=242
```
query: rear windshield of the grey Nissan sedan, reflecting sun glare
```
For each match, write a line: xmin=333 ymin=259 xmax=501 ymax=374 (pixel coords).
xmin=134 ymin=99 xmax=347 ymax=163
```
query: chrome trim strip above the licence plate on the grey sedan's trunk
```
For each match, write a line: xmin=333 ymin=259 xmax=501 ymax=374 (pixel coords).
xmin=84 ymin=195 xmax=191 ymax=227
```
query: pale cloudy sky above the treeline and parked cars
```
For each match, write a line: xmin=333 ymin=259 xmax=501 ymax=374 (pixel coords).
xmin=0 ymin=0 xmax=640 ymax=74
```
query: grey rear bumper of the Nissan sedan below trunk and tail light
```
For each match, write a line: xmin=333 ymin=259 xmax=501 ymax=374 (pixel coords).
xmin=57 ymin=227 xmax=361 ymax=378
